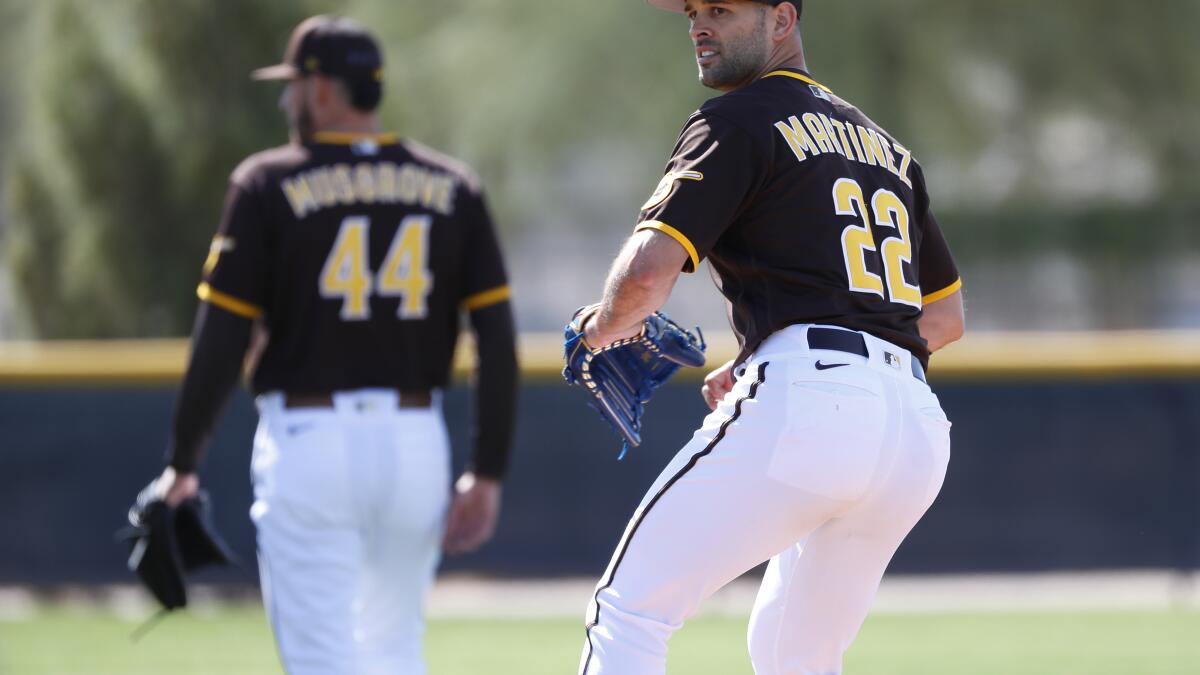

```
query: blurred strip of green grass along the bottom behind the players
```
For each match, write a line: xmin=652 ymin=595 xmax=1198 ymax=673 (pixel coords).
xmin=0 ymin=605 xmax=1200 ymax=675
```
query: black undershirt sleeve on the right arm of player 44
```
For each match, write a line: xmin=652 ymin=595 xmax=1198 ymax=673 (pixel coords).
xmin=468 ymin=300 xmax=517 ymax=480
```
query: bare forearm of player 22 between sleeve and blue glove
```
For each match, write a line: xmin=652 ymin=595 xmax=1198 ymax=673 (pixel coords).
xmin=584 ymin=229 xmax=688 ymax=347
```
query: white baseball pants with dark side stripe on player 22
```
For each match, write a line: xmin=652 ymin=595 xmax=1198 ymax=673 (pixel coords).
xmin=580 ymin=325 xmax=950 ymax=675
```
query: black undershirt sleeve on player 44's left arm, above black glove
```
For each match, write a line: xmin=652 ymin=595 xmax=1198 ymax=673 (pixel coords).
xmin=167 ymin=303 xmax=253 ymax=473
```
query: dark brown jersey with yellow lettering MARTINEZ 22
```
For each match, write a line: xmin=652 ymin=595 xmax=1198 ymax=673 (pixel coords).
xmin=637 ymin=68 xmax=961 ymax=363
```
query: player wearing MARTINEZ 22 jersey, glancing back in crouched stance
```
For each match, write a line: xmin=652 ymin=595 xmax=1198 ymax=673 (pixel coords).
xmin=580 ymin=0 xmax=964 ymax=675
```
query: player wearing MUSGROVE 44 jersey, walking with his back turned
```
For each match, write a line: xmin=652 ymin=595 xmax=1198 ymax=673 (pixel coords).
xmin=140 ymin=17 xmax=516 ymax=674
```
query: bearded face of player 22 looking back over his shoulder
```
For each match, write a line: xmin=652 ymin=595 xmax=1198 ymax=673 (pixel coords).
xmin=685 ymin=0 xmax=770 ymax=91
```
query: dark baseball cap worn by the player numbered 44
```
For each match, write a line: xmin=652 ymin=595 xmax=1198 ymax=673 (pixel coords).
xmin=251 ymin=14 xmax=383 ymax=85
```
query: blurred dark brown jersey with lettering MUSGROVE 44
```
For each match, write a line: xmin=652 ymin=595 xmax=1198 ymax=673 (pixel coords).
xmin=198 ymin=132 xmax=509 ymax=393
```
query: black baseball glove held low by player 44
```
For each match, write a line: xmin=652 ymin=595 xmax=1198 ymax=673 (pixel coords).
xmin=118 ymin=482 xmax=236 ymax=610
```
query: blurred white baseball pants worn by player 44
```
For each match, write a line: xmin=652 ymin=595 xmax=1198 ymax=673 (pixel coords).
xmin=251 ymin=389 xmax=450 ymax=675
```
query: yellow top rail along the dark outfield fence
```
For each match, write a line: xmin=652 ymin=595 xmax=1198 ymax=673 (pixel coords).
xmin=0 ymin=330 xmax=1200 ymax=387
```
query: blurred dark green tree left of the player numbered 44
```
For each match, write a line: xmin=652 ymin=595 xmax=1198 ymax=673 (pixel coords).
xmin=5 ymin=0 xmax=328 ymax=338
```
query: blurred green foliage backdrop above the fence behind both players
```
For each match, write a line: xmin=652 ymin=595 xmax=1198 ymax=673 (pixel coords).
xmin=0 ymin=0 xmax=1200 ymax=336
